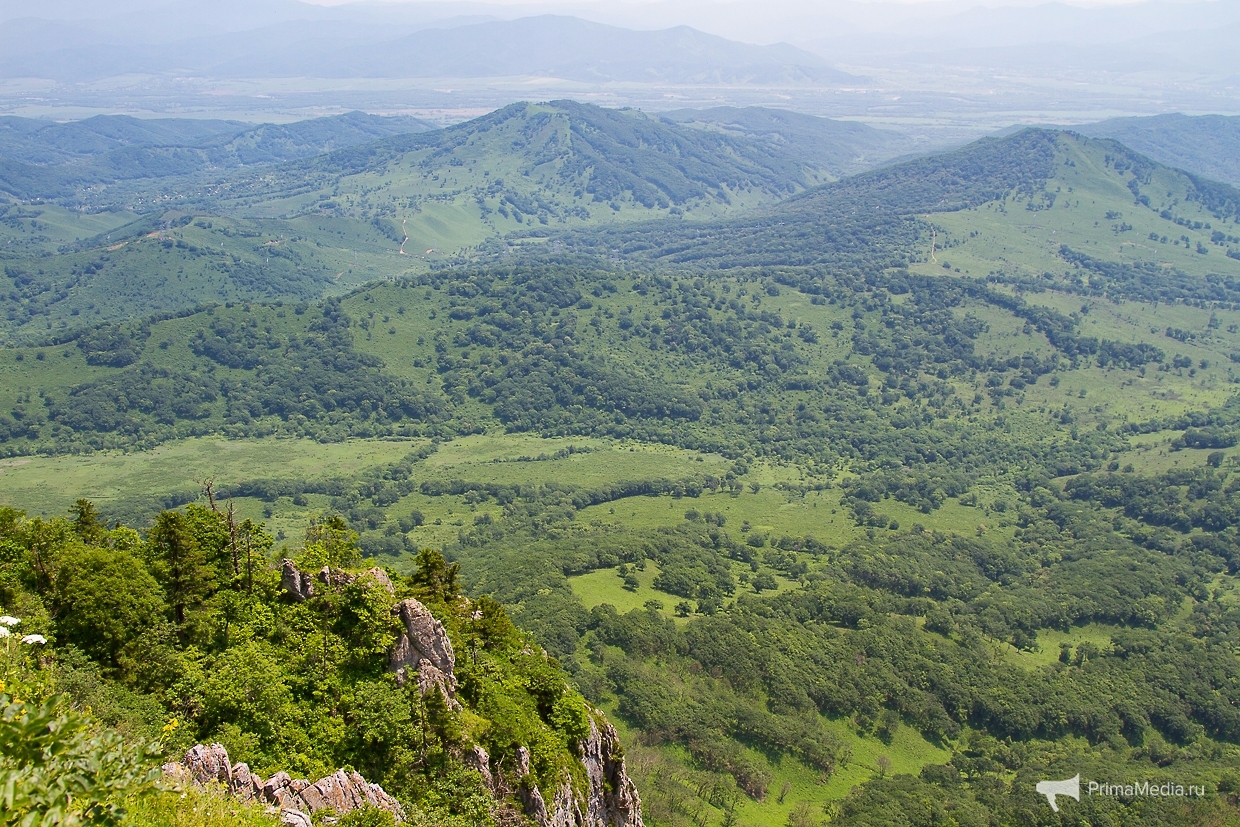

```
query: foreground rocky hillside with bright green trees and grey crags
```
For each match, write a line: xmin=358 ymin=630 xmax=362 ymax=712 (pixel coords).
xmin=0 ymin=500 xmax=642 ymax=827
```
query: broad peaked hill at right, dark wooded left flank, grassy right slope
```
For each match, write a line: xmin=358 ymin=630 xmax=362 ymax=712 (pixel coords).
xmin=565 ymin=129 xmax=1240 ymax=285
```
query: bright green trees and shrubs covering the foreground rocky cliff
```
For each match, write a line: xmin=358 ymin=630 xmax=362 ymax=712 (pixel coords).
xmin=0 ymin=501 xmax=607 ymax=826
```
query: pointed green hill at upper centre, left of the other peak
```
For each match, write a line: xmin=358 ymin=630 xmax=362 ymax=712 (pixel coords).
xmin=213 ymin=100 xmax=833 ymax=224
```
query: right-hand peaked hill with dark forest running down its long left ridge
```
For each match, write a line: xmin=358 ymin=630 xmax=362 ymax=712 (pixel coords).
xmin=565 ymin=129 xmax=1240 ymax=274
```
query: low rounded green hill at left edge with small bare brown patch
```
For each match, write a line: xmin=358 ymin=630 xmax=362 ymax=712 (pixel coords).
xmin=0 ymin=212 xmax=416 ymax=341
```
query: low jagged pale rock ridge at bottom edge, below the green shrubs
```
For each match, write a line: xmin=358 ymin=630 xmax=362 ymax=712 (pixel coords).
xmin=164 ymin=744 xmax=404 ymax=827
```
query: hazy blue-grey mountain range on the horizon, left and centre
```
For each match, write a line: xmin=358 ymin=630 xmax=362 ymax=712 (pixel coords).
xmin=0 ymin=2 xmax=863 ymax=86
